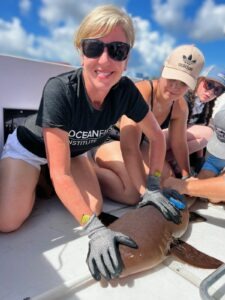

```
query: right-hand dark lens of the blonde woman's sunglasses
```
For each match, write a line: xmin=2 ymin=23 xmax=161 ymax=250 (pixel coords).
xmin=107 ymin=42 xmax=130 ymax=61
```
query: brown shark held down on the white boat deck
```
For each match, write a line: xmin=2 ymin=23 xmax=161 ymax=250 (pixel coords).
xmin=99 ymin=199 xmax=223 ymax=278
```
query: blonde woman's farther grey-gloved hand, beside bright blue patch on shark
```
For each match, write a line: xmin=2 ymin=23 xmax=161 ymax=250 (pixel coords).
xmin=137 ymin=175 xmax=185 ymax=224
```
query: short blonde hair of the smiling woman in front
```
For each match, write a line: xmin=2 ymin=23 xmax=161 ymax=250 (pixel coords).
xmin=74 ymin=5 xmax=135 ymax=49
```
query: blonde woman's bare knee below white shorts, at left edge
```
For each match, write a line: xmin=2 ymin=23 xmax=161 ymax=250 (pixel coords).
xmin=0 ymin=158 xmax=40 ymax=232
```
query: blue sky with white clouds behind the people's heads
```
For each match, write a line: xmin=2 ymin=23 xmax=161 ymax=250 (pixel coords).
xmin=0 ymin=0 xmax=225 ymax=76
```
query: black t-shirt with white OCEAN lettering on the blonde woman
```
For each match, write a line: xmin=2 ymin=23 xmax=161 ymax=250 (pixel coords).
xmin=17 ymin=68 xmax=148 ymax=157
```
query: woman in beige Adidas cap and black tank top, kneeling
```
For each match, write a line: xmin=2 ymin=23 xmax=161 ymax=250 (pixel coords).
xmin=94 ymin=45 xmax=204 ymax=205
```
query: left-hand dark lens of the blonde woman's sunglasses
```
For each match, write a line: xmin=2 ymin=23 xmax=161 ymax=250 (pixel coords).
xmin=81 ymin=39 xmax=104 ymax=58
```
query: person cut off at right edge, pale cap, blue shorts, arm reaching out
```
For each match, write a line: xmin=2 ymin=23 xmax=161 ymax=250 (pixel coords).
xmin=163 ymin=105 xmax=225 ymax=203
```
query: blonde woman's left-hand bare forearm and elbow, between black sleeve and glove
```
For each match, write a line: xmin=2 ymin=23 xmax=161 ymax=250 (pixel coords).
xmin=43 ymin=128 xmax=93 ymax=222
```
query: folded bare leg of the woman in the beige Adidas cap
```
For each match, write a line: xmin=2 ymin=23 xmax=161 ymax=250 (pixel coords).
xmin=93 ymin=141 xmax=140 ymax=205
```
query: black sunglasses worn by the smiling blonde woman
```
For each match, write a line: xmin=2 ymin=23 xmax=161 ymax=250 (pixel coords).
xmin=81 ymin=39 xmax=130 ymax=61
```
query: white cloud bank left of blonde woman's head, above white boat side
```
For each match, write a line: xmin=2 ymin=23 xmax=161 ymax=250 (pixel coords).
xmin=0 ymin=18 xmax=79 ymax=65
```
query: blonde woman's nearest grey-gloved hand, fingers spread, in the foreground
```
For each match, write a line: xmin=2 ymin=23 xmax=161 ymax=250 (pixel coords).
xmin=84 ymin=215 xmax=138 ymax=280
